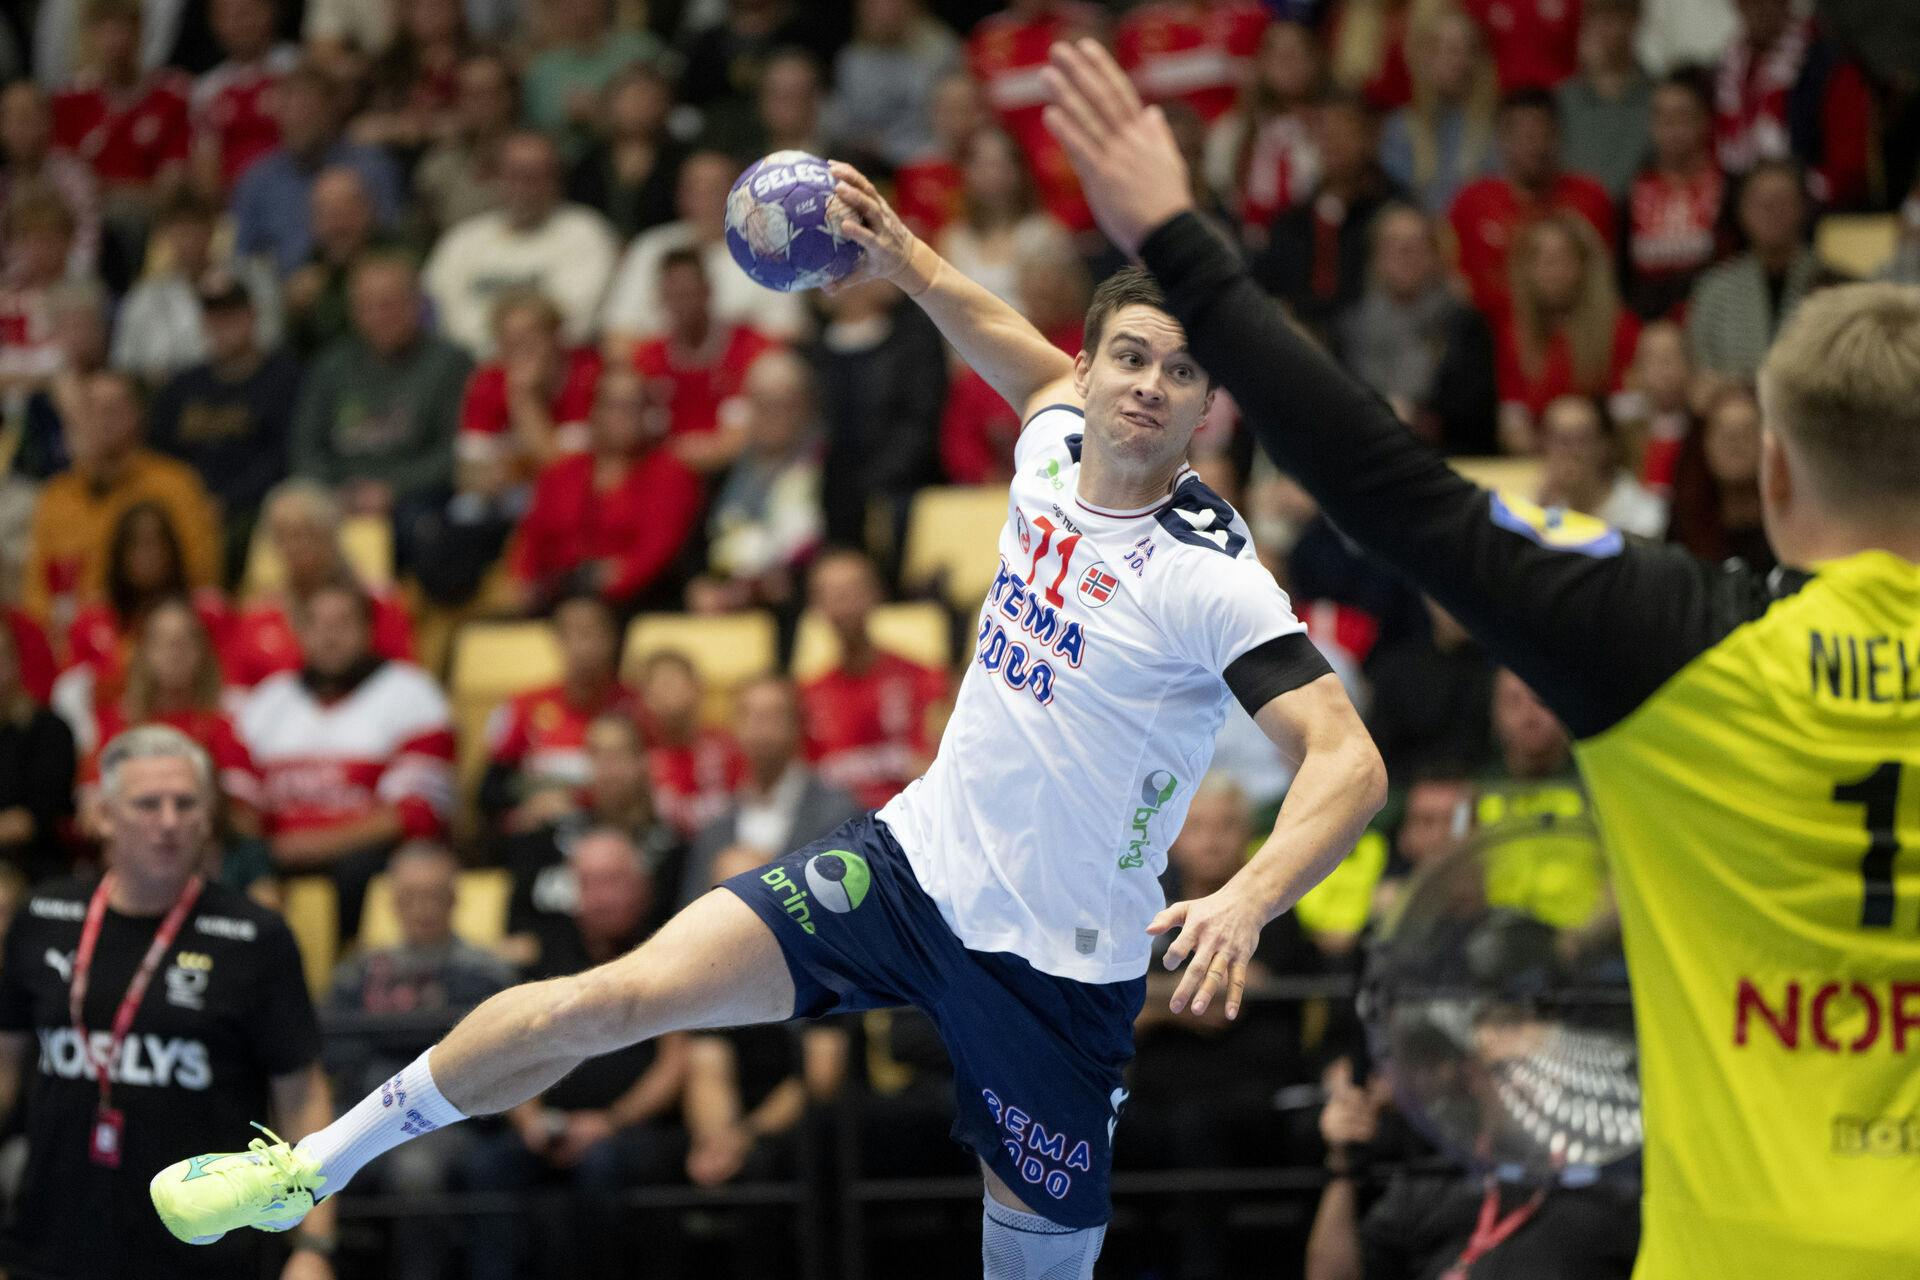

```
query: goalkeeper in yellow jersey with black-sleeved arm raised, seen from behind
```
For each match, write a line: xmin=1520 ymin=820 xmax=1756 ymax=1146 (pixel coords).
xmin=1046 ymin=42 xmax=1920 ymax=1280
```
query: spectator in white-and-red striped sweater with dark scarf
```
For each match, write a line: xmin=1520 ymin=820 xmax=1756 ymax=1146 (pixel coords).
xmin=240 ymin=580 xmax=453 ymax=938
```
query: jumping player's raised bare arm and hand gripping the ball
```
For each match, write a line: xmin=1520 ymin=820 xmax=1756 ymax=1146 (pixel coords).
xmin=826 ymin=159 xmax=1079 ymax=420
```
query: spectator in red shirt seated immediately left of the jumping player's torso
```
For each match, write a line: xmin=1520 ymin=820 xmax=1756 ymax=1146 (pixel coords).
xmin=801 ymin=551 xmax=948 ymax=808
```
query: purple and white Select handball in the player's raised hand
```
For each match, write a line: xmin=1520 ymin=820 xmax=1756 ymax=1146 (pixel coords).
xmin=726 ymin=152 xmax=860 ymax=294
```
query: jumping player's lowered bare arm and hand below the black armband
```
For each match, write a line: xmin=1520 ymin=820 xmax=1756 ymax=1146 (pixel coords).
xmin=1146 ymin=674 xmax=1386 ymax=1017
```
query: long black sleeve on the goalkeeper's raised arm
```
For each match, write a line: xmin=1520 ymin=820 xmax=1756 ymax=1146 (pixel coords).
xmin=1140 ymin=213 xmax=1766 ymax=737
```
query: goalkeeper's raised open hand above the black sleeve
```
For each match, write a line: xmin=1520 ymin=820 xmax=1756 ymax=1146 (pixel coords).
xmin=1041 ymin=40 xmax=1194 ymax=253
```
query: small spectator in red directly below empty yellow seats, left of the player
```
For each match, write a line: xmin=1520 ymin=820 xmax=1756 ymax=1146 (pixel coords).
xmin=639 ymin=649 xmax=747 ymax=837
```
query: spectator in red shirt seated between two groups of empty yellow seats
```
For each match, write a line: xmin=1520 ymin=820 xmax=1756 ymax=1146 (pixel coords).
xmin=480 ymin=595 xmax=639 ymax=835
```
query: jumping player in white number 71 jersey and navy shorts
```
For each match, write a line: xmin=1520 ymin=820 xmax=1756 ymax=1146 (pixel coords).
xmin=152 ymin=165 xmax=1386 ymax=1280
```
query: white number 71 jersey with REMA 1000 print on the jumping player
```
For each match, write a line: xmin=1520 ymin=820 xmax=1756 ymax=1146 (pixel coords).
xmin=879 ymin=405 xmax=1304 ymax=983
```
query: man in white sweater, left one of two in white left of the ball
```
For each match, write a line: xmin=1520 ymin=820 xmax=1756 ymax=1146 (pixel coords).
xmin=424 ymin=132 xmax=618 ymax=357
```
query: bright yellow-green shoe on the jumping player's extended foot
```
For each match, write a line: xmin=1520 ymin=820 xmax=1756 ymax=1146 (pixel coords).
xmin=148 ymin=1125 xmax=326 ymax=1244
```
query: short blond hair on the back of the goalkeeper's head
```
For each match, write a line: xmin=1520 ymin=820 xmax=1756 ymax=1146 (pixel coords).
xmin=1761 ymin=284 xmax=1920 ymax=503
